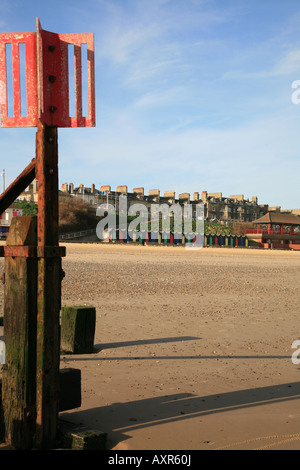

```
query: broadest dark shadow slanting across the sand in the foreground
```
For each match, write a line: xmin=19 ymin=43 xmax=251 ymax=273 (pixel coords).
xmin=62 ymin=382 xmax=300 ymax=449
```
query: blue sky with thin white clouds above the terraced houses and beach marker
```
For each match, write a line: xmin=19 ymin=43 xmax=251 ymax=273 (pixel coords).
xmin=0 ymin=0 xmax=300 ymax=209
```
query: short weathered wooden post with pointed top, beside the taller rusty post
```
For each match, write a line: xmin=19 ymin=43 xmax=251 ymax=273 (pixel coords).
xmin=2 ymin=217 xmax=37 ymax=449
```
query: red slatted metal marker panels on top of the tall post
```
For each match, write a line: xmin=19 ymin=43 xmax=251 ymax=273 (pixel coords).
xmin=0 ymin=18 xmax=95 ymax=127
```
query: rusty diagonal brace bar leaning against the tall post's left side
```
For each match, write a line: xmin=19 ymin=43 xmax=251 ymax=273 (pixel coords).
xmin=0 ymin=158 xmax=35 ymax=214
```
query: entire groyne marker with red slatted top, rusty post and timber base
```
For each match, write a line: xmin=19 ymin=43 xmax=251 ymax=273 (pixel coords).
xmin=0 ymin=18 xmax=95 ymax=449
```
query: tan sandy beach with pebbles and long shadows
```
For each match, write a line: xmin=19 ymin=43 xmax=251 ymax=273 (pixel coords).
xmin=0 ymin=243 xmax=300 ymax=450
